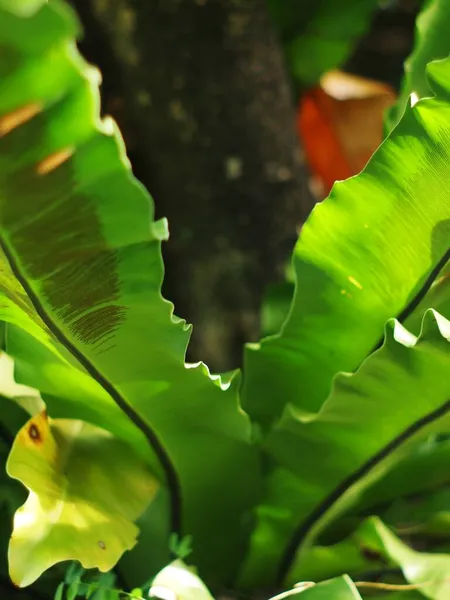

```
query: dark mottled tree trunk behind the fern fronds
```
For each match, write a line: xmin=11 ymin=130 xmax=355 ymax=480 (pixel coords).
xmin=73 ymin=0 xmax=313 ymax=371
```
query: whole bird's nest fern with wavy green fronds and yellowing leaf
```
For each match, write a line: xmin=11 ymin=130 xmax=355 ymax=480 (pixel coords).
xmin=0 ymin=0 xmax=450 ymax=600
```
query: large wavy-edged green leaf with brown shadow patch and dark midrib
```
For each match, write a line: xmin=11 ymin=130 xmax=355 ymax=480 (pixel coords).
xmin=0 ymin=0 xmax=259 ymax=579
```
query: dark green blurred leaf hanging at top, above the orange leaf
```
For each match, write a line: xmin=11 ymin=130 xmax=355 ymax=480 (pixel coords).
xmin=269 ymin=0 xmax=379 ymax=86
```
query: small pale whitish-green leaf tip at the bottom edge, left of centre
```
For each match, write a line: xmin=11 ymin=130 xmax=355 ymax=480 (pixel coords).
xmin=149 ymin=560 xmax=214 ymax=600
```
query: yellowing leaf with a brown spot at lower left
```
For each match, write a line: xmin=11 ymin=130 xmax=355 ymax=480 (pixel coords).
xmin=7 ymin=413 xmax=158 ymax=587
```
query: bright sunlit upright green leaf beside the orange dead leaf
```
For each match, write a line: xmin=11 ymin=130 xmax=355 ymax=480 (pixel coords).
xmin=243 ymin=54 xmax=450 ymax=425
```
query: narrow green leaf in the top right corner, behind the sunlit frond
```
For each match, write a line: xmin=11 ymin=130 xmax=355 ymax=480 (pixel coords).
xmin=388 ymin=0 xmax=450 ymax=127
